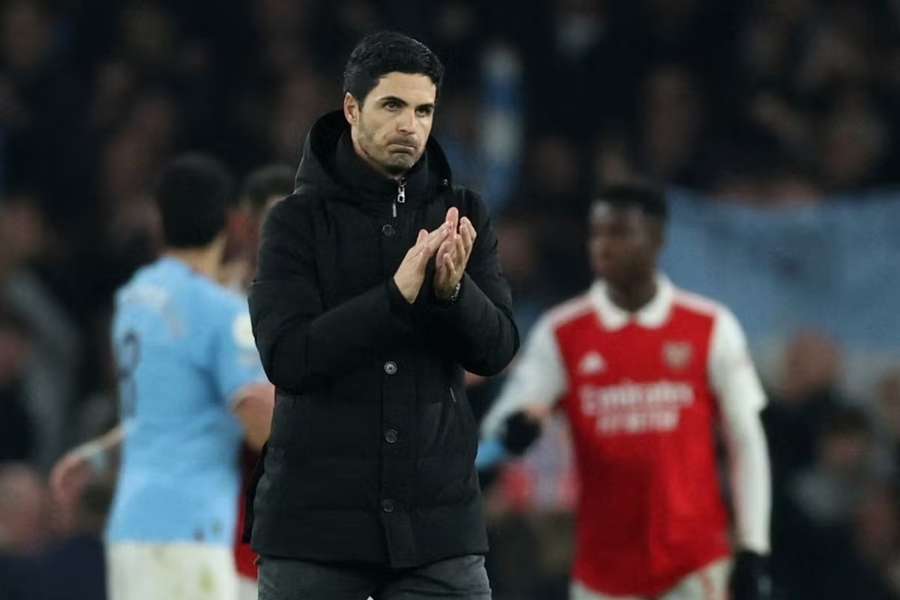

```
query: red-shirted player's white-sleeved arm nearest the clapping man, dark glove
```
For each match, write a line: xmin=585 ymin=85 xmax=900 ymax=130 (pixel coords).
xmin=476 ymin=316 xmax=567 ymax=468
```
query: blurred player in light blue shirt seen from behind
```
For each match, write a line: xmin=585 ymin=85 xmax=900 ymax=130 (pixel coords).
xmin=54 ymin=155 xmax=274 ymax=600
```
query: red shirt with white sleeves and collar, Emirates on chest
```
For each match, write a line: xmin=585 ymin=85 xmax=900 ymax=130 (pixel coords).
xmin=483 ymin=275 xmax=770 ymax=597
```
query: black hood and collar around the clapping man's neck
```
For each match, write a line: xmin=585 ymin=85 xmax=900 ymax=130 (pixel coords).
xmin=294 ymin=110 xmax=452 ymax=209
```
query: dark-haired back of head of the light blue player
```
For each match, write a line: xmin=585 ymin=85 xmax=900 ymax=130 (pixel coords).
xmin=156 ymin=154 xmax=234 ymax=248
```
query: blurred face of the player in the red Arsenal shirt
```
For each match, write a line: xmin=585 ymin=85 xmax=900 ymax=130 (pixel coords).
xmin=588 ymin=202 xmax=662 ymax=285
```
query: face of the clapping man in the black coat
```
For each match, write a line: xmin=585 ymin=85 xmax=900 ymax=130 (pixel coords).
xmin=344 ymin=73 xmax=437 ymax=176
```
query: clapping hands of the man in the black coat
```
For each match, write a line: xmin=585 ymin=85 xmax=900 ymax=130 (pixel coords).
xmin=394 ymin=206 xmax=476 ymax=304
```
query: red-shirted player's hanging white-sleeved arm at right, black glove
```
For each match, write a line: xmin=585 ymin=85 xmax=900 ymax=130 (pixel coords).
xmin=710 ymin=310 xmax=771 ymax=600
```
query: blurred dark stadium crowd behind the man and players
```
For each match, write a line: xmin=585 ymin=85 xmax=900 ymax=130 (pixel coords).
xmin=0 ymin=0 xmax=900 ymax=600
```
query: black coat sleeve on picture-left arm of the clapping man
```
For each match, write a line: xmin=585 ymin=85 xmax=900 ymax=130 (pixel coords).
xmin=249 ymin=196 xmax=412 ymax=391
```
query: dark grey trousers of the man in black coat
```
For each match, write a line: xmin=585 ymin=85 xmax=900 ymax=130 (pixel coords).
xmin=259 ymin=554 xmax=491 ymax=600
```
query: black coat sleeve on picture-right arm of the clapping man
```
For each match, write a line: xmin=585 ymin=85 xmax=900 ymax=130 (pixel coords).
xmin=425 ymin=192 xmax=519 ymax=375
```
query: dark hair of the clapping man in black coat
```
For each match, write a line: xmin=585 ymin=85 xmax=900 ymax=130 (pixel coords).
xmin=344 ymin=31 xmax=444 ymax=103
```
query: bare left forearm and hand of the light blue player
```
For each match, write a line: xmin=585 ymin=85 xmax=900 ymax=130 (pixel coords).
xmin=50 ymin=423 xmax=125 ymax=506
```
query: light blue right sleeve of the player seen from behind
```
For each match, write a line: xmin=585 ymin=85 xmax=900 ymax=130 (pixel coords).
xmin=213 ymin=300 xmax=267 ymax=406
